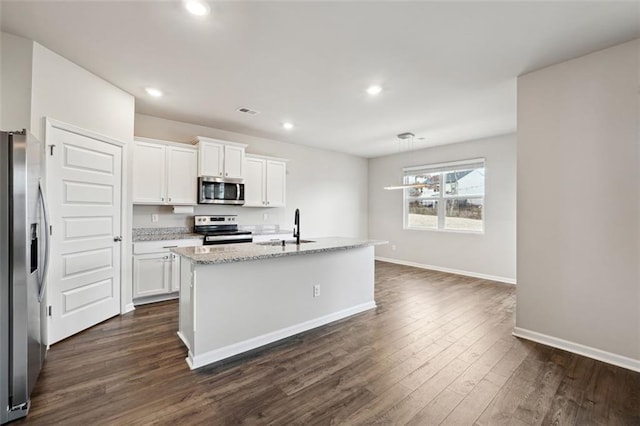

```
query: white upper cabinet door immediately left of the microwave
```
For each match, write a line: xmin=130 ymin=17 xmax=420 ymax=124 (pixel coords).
xmin=167 ymin=146 xmax=198 ymax=205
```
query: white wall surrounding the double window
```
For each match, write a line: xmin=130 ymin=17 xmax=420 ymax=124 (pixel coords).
xmin=369 ymin=134 xmax=516 ymax=282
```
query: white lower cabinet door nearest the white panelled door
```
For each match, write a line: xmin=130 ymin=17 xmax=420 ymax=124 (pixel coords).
xmin=133 ymin=253 xmax=170 ymax=299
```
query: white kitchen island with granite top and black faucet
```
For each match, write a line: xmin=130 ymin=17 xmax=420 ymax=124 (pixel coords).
xmin=172 ymin=238 xmax=385 ymax=369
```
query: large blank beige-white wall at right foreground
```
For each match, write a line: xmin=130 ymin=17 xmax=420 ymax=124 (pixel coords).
xmin=516 ymin=41 xmax=640 ymax=369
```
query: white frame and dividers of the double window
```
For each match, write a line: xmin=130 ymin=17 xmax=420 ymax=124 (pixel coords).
xmin=402 ymin=158 xmax=487 ymax=234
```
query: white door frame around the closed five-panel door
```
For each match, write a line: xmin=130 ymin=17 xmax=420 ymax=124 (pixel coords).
xmin=43 ymin=117 xmax=135 ymax=342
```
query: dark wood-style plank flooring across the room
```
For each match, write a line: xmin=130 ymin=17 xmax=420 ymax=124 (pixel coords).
xmin=17 ymin=262 xmax=640 ymax=425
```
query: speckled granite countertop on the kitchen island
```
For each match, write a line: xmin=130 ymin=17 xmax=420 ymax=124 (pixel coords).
xmin=171 ymin=237 xmax=387 ymax=265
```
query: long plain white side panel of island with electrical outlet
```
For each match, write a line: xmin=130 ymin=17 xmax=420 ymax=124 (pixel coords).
xmin=189 ymin=246 xmax=375 ymax=368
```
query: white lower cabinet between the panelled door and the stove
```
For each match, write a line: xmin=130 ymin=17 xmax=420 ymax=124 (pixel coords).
xmin=133 ymin=239 xmax=202 ymax=304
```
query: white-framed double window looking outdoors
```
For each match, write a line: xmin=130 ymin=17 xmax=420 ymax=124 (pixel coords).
xmin=403 ymin=159 xmax=484 ymax=232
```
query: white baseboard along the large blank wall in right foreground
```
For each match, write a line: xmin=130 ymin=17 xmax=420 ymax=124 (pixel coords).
xmin=512 ymin=327 xmax=640 ymax=372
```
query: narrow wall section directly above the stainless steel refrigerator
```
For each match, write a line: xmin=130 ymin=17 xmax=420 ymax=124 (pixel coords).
xmin=0 ymin=32 xmax=33 ymax=131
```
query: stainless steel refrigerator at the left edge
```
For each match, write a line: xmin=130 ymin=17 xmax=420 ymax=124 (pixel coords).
xmin=0 ymin=131 xmax=49 ymax=424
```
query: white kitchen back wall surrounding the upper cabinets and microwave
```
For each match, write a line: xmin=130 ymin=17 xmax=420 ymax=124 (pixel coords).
xmin=133 ymin=114 xmax=367 ymax=237
